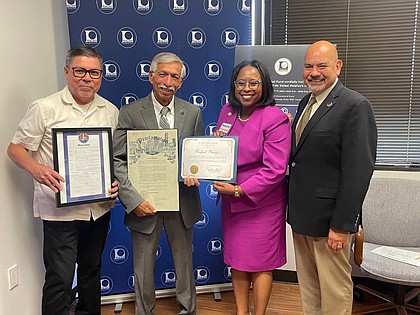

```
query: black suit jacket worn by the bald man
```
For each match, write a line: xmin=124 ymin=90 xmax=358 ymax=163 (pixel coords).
xmin=287 ymin=82 xmax=377 ymax=236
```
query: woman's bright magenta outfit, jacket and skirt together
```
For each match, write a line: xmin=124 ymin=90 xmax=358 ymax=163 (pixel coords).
xmin=217 ymin=105 xmax=291 ymax=272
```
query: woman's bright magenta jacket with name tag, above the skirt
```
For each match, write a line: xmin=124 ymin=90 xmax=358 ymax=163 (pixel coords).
xmin=217 ymin=104 xmax=291 ymax=212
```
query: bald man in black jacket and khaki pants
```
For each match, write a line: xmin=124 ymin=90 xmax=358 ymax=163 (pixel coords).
xmin=287 ymin=41 xmax=377 ymax=315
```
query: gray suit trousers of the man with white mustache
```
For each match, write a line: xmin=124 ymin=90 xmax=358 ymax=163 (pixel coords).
xmin=131 ymin=212 xmax=196 ymax=315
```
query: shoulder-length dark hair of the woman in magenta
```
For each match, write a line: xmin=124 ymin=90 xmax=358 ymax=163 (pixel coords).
xmin=228 ymin=60 xmax=276 ymax=109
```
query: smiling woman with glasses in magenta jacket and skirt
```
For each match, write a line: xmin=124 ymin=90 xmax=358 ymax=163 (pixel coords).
xmin=214 ymin=60 xmax=291 ymax=315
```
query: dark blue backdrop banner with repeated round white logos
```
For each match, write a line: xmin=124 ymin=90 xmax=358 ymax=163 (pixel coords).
xmin=66 ymin=0 xmax=251 ymax=295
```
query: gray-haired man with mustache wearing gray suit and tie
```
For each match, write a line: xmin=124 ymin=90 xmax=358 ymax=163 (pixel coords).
xmin=114 ymin=52 xmax=203 ymax=315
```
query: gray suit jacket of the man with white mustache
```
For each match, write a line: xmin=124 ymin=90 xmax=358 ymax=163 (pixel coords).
xmin=113 ymin=94 xmax=204 ymax=233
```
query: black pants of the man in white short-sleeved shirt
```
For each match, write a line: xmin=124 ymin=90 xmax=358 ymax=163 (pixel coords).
xmin=42 ymin=212 xmax=110 ymax=315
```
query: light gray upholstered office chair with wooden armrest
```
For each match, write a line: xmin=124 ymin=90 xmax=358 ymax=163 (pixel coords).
xmin=353 ymin=178 xmax=420 ymax=315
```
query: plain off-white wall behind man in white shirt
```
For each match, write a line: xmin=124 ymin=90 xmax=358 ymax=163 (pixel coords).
xmin=0 ymin=0 xmax=69 ymax=315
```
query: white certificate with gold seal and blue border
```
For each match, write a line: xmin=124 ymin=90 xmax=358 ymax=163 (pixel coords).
xmin=179 ymin=136 xmax=238 ymax=183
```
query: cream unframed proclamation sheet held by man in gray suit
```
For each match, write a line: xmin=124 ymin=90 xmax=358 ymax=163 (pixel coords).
xmin=127 ymin=129 xmax=179 ymax=211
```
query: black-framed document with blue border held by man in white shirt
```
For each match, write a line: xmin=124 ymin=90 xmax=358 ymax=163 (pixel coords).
xmin=51 ymin=127 xmax=114 ymax=207
